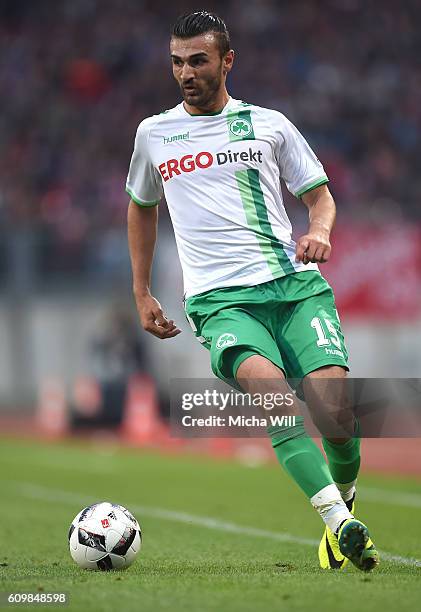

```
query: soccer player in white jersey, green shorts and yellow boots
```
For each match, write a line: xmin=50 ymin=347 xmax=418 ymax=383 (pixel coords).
xmin=126 ymin=11 xmax=378 ymax=571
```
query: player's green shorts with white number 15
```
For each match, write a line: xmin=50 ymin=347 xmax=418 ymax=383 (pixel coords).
xmin=185 ymin=270 xmax=348 ymax=384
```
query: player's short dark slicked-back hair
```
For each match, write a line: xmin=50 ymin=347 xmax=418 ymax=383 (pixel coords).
xmin=171 ymin=11 xmax=231 ymax=57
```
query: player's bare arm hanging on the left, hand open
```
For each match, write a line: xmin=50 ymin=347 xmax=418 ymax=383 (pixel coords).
xmin=127 ymin=200 xmax=181 ymax=339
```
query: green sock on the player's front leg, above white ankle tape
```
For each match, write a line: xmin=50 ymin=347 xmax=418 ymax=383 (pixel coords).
xmin=267 ymin=416 xmax=334 ymax=498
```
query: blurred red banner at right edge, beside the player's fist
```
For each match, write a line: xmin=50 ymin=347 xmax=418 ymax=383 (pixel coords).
xmin=322 ymin=224 xmax=421 ymax=321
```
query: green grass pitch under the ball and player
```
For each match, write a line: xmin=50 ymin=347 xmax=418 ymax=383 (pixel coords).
xmin=0 ymin=440 xmax=421 ymax=612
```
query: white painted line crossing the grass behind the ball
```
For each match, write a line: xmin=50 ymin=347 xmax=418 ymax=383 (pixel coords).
xmin=8 ymin=483 xmax=421 ymax=567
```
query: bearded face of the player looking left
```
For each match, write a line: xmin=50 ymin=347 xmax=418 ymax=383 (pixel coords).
xmin=170 ymin=32 xmax=233 ymax=108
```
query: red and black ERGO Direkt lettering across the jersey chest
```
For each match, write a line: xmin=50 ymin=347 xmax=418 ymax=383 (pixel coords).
xmin=158 ymin=147 xmax=263 ymax=181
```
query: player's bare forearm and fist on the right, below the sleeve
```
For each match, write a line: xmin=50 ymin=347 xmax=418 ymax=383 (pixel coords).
xmin=295 ymin=185 xmax=336 ymax=264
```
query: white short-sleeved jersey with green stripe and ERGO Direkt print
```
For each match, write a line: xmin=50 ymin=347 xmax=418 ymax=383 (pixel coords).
xmin=126 ymin=98 xmax=328 ymax=297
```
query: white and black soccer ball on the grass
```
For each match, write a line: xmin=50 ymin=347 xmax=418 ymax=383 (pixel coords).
xmin=69 ymin=502 xmax=142 ymax=571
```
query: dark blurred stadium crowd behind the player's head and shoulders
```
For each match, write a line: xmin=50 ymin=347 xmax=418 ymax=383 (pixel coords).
xmin=0 ymin=0 xmax=421 ymax=286
